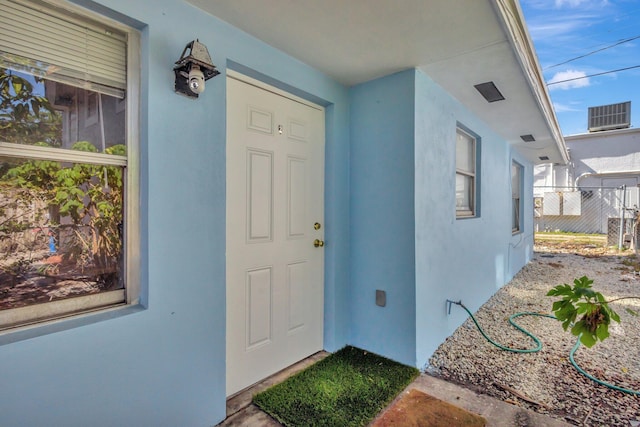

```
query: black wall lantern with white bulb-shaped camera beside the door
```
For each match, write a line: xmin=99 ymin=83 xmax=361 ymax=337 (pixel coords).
xmin=173 ymin=39 xmax=220 ymax=98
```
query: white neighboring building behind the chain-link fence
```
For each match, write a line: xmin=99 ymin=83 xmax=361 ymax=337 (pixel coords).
xmin=534 ymin=128 xmax=640 ymax=236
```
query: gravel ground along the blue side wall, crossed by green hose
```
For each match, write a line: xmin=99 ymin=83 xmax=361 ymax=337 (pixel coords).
xmin=428 ymin=252 xmax=640 ymax=427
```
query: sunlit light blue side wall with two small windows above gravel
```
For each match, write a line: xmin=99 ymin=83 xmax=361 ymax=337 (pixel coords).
xmin=415 ymin=72 xmax=533 ymax=367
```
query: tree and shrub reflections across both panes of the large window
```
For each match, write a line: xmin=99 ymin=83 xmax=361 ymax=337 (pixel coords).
xmin=0 ymin=68 xmax=126 ymax=282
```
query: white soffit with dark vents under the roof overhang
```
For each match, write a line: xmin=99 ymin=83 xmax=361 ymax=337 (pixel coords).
xmin=187 ymin=0 xmax=564 ymax=163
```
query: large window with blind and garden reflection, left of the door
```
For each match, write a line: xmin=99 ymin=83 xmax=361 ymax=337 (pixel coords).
xmin=0 ymin=0 xmax=139 ymax=333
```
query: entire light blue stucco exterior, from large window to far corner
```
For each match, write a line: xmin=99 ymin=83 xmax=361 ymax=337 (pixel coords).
xmin=0 ymin=0 xmax=532 ymax=427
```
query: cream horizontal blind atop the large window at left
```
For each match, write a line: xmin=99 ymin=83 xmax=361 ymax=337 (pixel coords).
xmin=0 ymin=0 xmax=127 ymax=98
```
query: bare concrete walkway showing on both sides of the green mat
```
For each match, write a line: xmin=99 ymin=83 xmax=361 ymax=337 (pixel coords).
xmin=219 ymin=352 xmax=571 ymax=427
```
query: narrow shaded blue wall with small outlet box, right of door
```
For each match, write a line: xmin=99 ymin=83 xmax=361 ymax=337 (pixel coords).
xmin=350 ymin=70 xmax=415 ymax=365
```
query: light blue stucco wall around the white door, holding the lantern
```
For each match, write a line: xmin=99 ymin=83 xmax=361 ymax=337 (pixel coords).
xmin=0 ymin=0 xmax=349 ymax=427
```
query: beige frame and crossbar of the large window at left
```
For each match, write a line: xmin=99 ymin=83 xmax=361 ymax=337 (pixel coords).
xmin=0 ymin=0 xmax=141 ymax=332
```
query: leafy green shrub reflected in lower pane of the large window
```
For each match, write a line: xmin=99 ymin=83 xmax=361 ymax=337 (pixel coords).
xmin=0 ymin=141 xmax=126 ymax=270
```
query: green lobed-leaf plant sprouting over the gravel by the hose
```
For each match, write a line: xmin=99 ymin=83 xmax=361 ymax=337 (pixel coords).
xmin=547 ymin=276 xmax=620 ymax=347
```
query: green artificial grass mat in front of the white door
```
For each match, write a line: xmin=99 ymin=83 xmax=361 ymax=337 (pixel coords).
xmin=253 ymin=347 xmax=419 ymax=427
